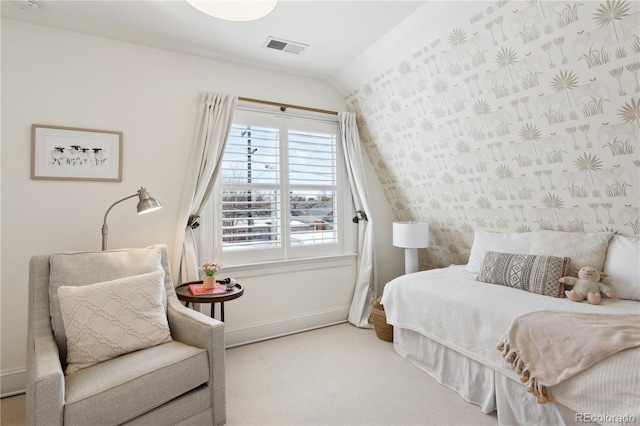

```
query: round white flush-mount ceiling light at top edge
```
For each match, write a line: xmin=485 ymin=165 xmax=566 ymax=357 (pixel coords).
xmin=187 ymin=0 xmax=278 ymax=21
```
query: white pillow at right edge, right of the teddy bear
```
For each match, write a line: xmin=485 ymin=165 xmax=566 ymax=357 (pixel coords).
xmin=602 ymin=235 xmax=640 ymax=301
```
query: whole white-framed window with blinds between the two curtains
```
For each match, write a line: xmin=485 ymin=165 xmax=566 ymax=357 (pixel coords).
xmin=202 ymin=109 xmax=351 ymax=264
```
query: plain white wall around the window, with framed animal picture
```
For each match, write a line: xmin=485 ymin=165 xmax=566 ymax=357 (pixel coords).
xmin=0 ymin=19 xmax=402 ymax=395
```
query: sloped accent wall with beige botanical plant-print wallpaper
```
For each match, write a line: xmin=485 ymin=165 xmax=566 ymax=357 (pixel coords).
xmin=347 ymin=0 xmax=640 ymax=269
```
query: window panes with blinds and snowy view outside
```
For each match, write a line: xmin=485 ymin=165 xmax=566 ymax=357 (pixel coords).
xmin=222 ymin=119 xmax=338 ymax=251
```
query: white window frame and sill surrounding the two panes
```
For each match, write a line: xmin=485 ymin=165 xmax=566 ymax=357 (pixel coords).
xmin=196 ymin=104 xmax=356 ymax=267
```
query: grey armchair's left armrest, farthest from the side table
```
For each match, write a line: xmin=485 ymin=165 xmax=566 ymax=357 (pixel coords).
xmin=27 ymin=335 xmax=64 ymax=425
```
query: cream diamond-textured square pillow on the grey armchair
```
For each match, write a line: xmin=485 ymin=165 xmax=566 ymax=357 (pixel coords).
xmin=58 ymin=271 xmax=171 ymax=374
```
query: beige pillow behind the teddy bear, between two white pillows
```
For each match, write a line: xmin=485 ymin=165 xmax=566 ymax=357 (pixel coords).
xmin=529 ymin=230 xmax=613 ymax=276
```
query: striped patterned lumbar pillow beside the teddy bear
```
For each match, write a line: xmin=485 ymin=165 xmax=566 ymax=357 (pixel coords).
xmin=476 ymin=251 xmax=571 ymax=297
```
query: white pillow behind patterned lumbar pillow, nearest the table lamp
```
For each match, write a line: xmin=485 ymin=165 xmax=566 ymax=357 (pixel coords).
xmin=466 ymin=231 xmax=533 ymax=274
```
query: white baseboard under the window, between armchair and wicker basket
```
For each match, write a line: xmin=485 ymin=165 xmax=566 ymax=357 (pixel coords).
xmin=225 ymin=306 xmax=349 ymax=348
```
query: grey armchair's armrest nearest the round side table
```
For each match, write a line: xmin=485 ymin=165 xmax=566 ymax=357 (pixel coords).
xmin=167 ymin=297 xmax=227 ymax=425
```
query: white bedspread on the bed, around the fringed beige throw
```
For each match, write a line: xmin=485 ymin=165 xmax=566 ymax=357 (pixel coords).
xmin=382 ymin=266 xmax=640 ymax=423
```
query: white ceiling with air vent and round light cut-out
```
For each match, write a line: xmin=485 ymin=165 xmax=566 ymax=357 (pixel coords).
xmin=0 ymin=0 xmax=426 ymax=80
